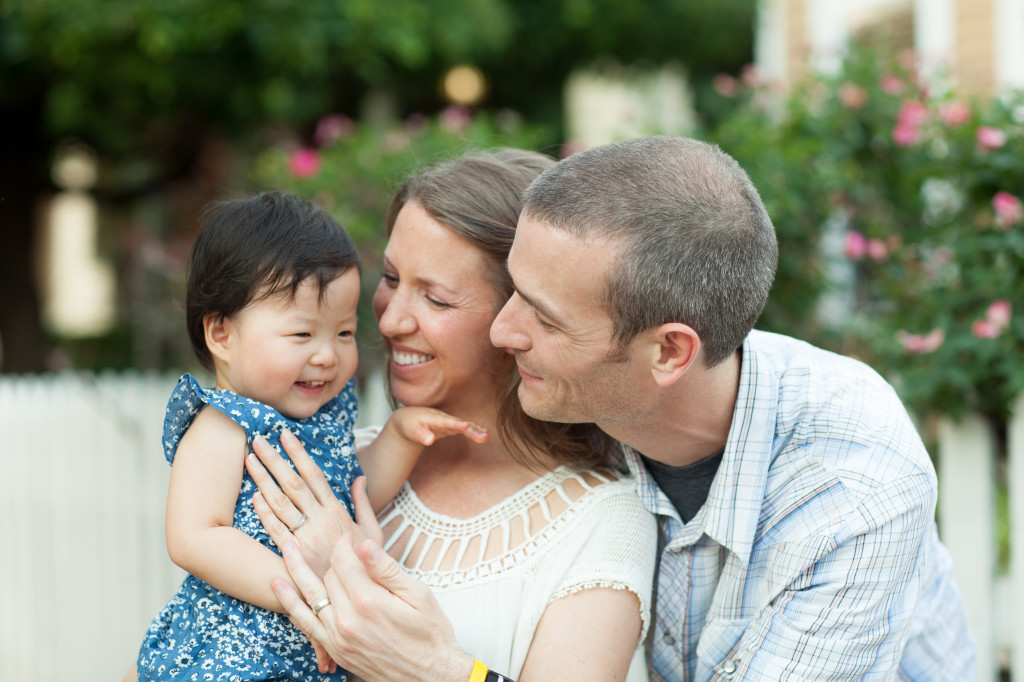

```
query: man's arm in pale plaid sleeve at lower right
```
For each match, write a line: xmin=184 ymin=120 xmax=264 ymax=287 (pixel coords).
xmin=723 ymin=474 xmax=935 ymax=680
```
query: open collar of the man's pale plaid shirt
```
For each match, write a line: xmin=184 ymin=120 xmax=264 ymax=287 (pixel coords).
xmin=623 ymin=332 xmax=779 ymax=563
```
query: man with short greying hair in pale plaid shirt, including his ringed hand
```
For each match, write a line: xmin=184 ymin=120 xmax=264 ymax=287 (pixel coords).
xmin=279 ymin=137 xmax=974 ymax=682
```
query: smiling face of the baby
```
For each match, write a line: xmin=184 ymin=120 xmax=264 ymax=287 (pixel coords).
xmin=216 ymin=268 xmax=359 ymax=419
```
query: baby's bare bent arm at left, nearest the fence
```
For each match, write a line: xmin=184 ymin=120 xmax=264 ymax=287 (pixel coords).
xmin=167 ymin=408 xmax=288 ymax=611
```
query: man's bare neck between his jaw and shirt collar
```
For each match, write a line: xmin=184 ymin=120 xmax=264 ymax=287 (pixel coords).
xmin=598 ymin=351 xmax=740 ymax=467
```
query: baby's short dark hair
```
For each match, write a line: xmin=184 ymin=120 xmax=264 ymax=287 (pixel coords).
xmin=185 ymin=191 xmax=359 ymax=371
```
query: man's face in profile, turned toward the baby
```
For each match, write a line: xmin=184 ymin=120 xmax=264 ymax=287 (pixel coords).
xmin=490 ymin=217 xmax=649 ymax=424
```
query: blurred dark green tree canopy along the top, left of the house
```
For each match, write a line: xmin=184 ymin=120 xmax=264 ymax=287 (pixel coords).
xmin=0 ymin=0 xmax=755 ymax=155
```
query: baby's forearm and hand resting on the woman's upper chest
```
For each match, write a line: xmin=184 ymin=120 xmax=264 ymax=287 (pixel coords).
xmin=357 ymin=408 xmax=487 ymax=512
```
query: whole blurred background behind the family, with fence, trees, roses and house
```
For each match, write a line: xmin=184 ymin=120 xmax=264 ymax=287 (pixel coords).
xmin=0 ymin=0 xmax=1024 ymax=681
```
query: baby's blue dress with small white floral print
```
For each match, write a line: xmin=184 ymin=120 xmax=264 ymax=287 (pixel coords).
xmin=137 ymin=374 xmax=361 ymax=682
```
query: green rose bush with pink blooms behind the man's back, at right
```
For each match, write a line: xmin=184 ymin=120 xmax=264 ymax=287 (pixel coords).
xmin=715 ymin=52 xmax=1024 ymax=418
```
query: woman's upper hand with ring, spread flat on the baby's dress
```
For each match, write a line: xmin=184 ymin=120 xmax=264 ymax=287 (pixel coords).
xmin=246 ymin=431 xmax=383 ymax=577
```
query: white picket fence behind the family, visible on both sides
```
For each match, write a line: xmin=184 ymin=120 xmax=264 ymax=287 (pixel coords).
xmin=0 ymin=373 xmax=1024 ymax=682
